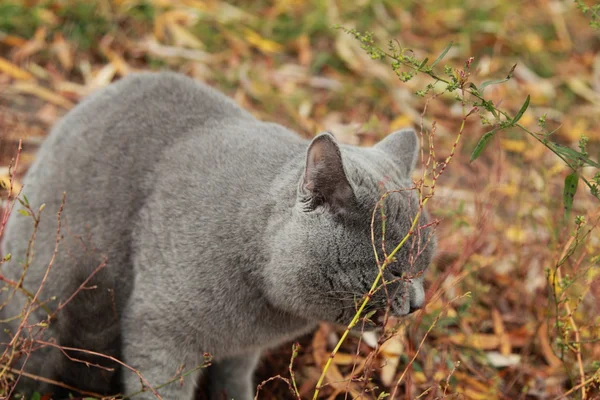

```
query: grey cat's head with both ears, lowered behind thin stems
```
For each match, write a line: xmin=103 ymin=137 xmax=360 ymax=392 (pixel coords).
xmin=266 ymin=129 xmax=435 ymax=324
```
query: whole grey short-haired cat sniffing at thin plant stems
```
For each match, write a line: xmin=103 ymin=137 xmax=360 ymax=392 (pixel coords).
xmin=1 ymin=73 xmax=434 ymax=400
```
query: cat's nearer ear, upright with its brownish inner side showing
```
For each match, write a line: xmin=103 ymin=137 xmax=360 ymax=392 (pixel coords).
xmin=300 ymin=132 xmax=354 ymax=211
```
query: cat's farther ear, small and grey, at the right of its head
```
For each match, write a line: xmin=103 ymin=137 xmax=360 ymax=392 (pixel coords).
xmin=375 ymin=128 xmax=419 ymax=175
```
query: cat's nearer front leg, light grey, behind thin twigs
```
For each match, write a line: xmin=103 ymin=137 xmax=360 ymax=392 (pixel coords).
xmin=122 ymin=294 xmax=203 ymax=400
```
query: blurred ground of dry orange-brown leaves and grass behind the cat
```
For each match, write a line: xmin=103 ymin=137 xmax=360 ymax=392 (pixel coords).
xmin=0 ymin=0 xmax=600 ymax=399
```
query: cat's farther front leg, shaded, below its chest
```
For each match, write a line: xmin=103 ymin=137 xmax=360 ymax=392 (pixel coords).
xmin=208 ymin=352 xmax=260 ymax=400
